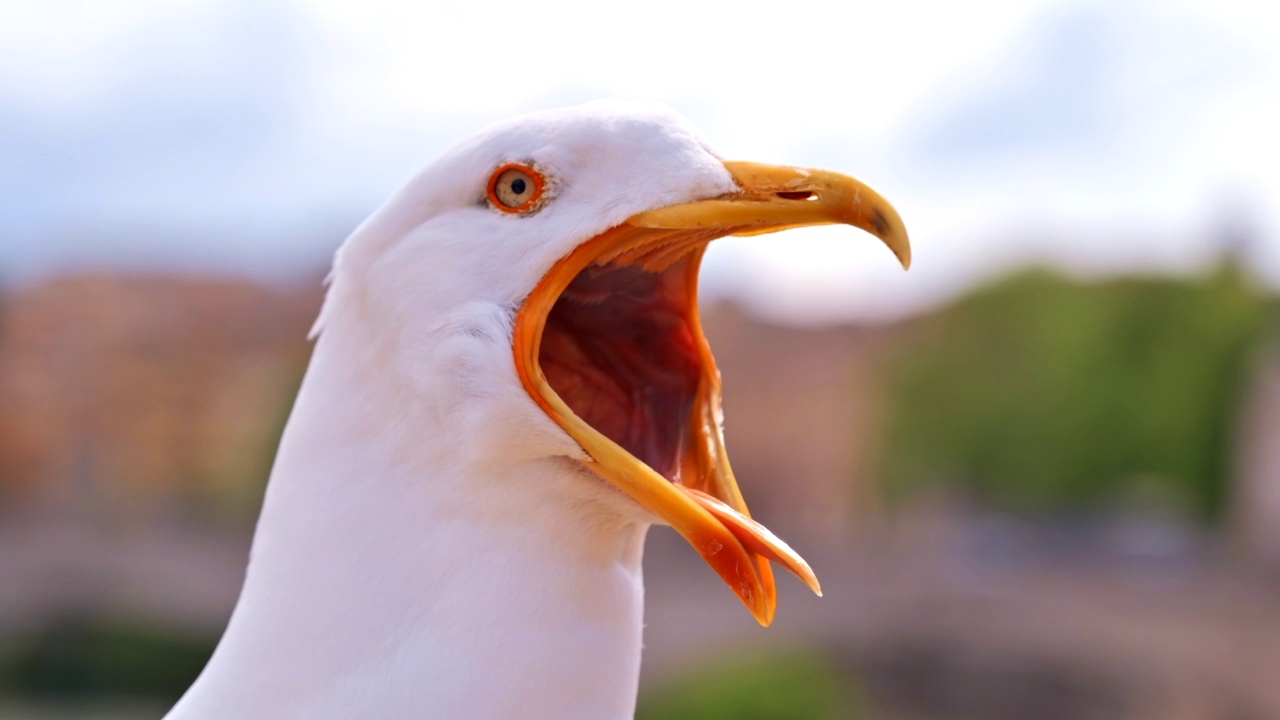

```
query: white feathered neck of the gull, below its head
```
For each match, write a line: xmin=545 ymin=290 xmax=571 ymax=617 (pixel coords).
xmin=169 ymin=313 xmax=648 ymax=720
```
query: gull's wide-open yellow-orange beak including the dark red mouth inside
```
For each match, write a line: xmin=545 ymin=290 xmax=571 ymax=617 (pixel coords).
xmin=513 ymin=163 xmax=911 ymax=625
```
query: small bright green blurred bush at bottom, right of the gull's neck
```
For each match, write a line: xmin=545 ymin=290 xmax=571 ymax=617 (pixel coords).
xmin=636 ymin=651 xmax=859 ymax=720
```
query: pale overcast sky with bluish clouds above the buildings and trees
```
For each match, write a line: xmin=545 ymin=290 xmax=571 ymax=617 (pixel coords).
xmin=0 ymin=0 xmax=1280 ymax=319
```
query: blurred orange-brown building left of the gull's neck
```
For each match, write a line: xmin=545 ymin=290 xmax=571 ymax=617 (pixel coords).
xmin=0 ymin=275 xmax=320 ymax=521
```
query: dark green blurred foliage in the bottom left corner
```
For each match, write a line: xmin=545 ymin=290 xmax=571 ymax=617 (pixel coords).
xmin=0 ymin=620 xmax=214 ymax=702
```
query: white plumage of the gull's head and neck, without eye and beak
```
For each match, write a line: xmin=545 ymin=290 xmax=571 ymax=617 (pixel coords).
xmin=169 ymin=102 xmax=733 ymax=720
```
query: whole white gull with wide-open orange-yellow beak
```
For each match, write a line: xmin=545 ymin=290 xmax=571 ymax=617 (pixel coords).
xmin=166 ymin=101 xmax=910 ymax=720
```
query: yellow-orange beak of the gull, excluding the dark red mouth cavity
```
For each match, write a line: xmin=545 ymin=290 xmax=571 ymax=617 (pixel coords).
xmin=513 ymin=163 xmax=911 ymax=625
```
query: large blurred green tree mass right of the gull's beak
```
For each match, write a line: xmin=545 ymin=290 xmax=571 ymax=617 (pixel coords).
xmin=884 ymin=264 xmax=1270 ymax=520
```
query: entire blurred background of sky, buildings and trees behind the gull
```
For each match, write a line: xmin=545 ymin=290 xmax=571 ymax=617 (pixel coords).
xmin=0 ymin=0 xmax=1280 ymax=720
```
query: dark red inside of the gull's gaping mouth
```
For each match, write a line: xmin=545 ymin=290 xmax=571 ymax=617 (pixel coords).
xmin=538 ymin=255 xmax=701 ymax=483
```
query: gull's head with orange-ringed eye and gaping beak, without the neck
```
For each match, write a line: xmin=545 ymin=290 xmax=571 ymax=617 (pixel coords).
xmin=317 ymin=102 xmax=910 ymax=625
